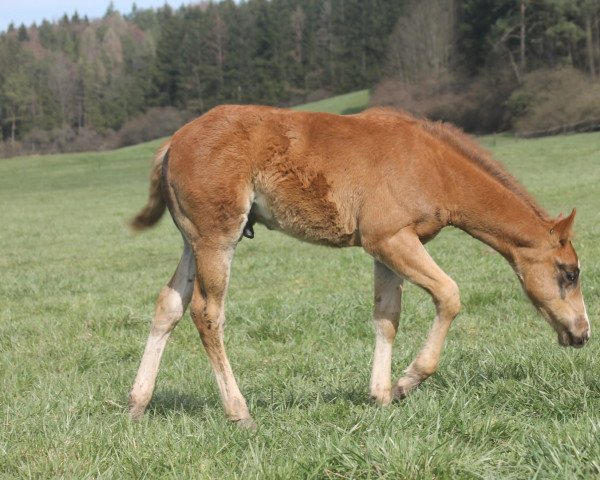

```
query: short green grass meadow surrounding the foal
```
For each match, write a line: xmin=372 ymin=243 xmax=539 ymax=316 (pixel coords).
xmin=0 ymin=124 xmax=600 ymax=479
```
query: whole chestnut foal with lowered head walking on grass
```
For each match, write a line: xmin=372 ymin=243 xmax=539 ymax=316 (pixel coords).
xmin=130 ymin=106 xmax=590 ymax=426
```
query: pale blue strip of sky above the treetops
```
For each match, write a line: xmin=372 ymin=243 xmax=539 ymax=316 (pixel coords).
xmin=0 ymin=0 xmax=188 ymax=31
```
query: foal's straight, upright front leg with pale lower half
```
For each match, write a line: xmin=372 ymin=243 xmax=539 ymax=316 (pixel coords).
xmin=370 ymin=260 xmax=404 ymax=405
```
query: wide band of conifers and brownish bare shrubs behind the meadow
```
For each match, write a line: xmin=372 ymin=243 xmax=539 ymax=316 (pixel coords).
xmin=0 ymin=0 xmax=600 ymax=156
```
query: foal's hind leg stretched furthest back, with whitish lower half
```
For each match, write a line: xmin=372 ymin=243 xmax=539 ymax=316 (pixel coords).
xmin=129 ymin=239 xmax=195 ymax=419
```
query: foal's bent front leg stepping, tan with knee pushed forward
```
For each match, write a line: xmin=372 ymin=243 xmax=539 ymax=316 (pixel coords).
xmin=367 ymin=227 xmax=460 ymax=398
